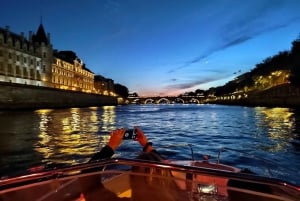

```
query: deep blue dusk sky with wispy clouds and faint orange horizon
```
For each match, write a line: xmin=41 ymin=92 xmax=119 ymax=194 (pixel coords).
xmin=0 ymin=0 xmax=300 ymax=96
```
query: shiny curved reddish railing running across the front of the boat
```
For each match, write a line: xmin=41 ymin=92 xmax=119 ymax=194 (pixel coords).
xmin=0 ymin=158 xmax=299 ymax=190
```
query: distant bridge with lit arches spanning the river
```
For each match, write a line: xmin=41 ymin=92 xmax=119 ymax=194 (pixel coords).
xmin=127 ymin=96 xmax=205 ymax=104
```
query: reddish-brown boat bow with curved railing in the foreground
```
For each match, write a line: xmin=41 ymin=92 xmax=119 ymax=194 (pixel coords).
xmin=0 ymin=152 xmax=300 ymax=201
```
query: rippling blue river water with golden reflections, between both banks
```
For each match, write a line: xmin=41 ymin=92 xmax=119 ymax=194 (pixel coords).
xmin=0 ymin=104 xmax=300 ymax=185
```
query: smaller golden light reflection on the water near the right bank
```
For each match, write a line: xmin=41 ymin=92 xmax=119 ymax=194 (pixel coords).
xmin=255 ymin=107 xmax=296 ymax=152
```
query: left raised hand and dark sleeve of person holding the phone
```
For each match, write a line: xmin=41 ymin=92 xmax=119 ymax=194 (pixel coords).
xmin=89 ymin=128 xmax=125 ymax=162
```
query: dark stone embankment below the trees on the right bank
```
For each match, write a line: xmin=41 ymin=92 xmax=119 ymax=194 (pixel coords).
xmin=210 ymin=84 xmax=300 ymax=107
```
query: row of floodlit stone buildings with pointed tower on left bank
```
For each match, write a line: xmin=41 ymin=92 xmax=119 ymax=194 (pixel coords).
xmin=0 ymin=24 xmax=115 ymax=95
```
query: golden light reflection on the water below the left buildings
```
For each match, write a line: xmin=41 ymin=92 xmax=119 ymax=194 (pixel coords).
xmin=34 ymin=107 xmax=115 ymax=165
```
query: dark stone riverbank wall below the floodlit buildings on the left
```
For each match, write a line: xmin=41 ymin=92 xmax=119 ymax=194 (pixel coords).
xmin=0 ymin=82 xmax=118 ymax=110
